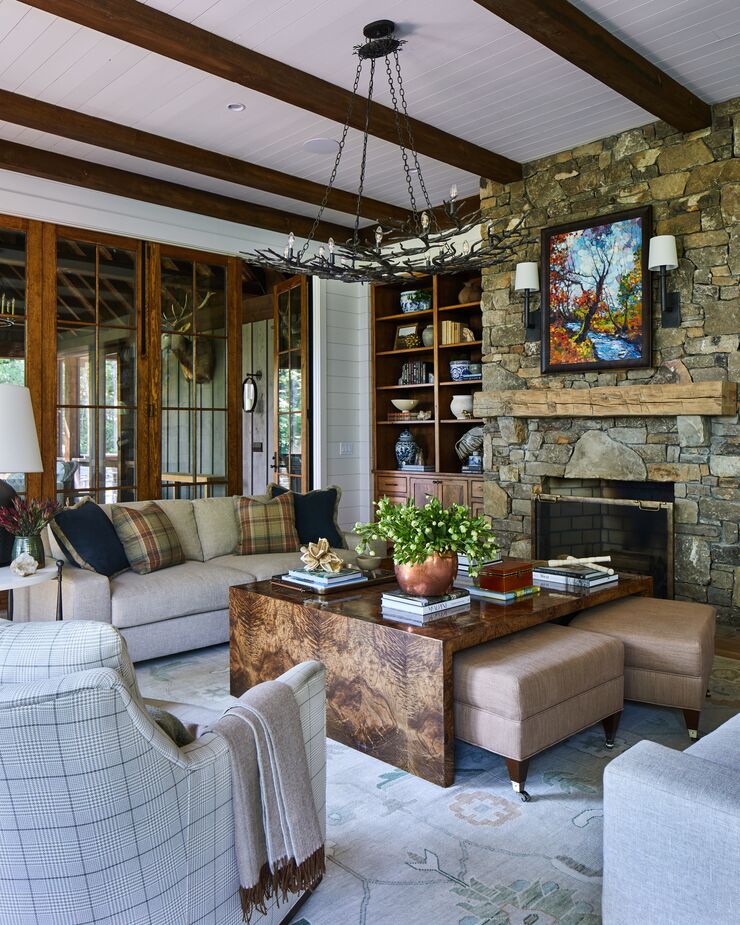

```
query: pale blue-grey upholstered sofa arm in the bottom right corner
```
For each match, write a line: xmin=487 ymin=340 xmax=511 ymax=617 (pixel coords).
xmin=602 ymin=742 xmax=740 ymax=925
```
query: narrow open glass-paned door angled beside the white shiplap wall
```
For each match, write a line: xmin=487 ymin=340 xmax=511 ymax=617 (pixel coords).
xmin=273 ymin=276 xmax=311 ymax=492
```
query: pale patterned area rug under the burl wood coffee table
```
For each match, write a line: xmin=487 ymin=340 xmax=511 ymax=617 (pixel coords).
xmin=137 ymin=646 xmax=740 ymax=925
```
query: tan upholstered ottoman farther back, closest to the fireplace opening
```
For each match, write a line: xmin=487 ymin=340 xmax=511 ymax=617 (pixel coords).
xmin=570 ymin=597 xmax=716 ymax=739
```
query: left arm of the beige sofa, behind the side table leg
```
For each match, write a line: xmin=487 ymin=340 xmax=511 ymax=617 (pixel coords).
xmin=13 ymin=565 xmax=111 ymax=623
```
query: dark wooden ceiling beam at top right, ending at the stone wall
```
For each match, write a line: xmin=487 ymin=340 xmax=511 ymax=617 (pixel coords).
xmin=476 ymin=0 xmax=712 ymax=132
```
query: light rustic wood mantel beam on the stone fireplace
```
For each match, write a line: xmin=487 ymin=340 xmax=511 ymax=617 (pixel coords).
xmin=473 ymin=381 xmax=737 ymax=418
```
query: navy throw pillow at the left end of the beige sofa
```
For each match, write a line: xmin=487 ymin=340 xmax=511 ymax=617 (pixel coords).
xmin=51 ymin=498 xmax=130 ymax=578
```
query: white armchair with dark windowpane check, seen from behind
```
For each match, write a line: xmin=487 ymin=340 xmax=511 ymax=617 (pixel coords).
xmin=0 ymin=620 xmax=326 ymax=925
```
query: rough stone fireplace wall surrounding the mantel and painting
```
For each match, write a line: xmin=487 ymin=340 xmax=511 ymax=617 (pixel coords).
xmin=481 ymin=98 xmax=740 ymax=626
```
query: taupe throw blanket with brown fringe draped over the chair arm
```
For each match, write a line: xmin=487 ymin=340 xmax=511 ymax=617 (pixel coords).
xmin=213 ymin=681 xmax=325 ymax=922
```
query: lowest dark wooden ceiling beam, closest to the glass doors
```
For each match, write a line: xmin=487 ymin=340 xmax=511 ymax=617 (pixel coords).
xmin=0 ymin=141 xmax=351 ymax=241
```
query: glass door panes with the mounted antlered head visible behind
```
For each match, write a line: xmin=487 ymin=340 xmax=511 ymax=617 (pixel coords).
xmin=160 ymin=251 xmax=228 ymax=498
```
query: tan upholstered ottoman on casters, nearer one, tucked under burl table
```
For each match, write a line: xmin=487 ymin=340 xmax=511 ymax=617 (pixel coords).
xmin=454 ymin=623 xmax=624 ymax=802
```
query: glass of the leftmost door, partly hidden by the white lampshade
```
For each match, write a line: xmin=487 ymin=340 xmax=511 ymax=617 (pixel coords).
xmin=0 ymin=228 xmax=26 ymax=492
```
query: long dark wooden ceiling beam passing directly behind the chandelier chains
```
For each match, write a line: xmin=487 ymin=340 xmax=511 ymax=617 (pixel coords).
xmin=24 ymin=0 xmax=522 ymax=183
